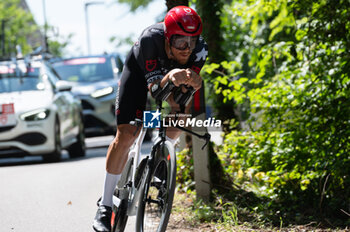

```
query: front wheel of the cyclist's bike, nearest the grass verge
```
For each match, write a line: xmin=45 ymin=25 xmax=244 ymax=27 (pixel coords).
xmin=136 ymin=142 xmax=176 ymax=232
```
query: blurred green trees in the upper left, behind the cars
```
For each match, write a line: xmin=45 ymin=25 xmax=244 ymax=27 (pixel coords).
xmin=0 ymin=0 xmax=73 ymax=59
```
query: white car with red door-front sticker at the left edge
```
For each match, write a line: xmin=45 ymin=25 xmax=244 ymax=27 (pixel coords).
xmin=0 ymin=59 xmax=85 ymax=161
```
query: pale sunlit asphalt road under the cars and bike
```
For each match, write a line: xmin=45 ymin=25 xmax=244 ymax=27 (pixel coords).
xmin=0 ymin=136 xmax=151 ymax=232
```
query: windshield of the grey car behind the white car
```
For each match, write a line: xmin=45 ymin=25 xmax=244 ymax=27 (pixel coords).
xmin=53 ymin=57 xmax=113 ymax=82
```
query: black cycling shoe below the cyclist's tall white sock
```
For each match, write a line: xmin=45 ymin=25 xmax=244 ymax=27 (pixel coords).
xmin=92 ymin=205 xmax=112 ymax=232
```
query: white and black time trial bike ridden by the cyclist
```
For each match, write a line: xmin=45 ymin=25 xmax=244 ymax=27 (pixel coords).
xmin=111 ymin=94 xmax=210 ymax=232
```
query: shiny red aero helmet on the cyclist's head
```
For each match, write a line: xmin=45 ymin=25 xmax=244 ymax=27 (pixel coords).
xmin=164 ymin=6 xmax=203 ymax=41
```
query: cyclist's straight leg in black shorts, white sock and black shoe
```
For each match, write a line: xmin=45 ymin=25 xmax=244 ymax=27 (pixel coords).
xmin=94 ymin=49 xmax=148 ymax=231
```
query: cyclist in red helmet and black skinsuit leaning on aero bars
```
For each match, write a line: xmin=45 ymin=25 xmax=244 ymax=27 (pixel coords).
xmin=93 ymin=6 xmax=208 ymax=231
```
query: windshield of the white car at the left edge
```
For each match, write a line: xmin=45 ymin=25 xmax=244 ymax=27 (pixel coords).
xmin=0 ymin=66 xmax=45 ymax=93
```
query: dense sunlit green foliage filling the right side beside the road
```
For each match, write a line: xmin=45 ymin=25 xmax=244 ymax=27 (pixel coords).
xmin=205 ymin=0 xmax=350 ymax=225
